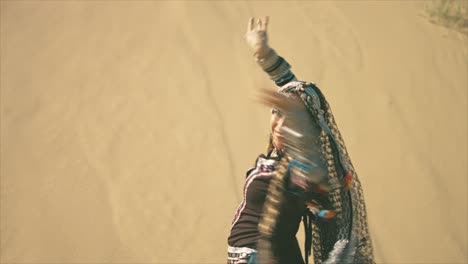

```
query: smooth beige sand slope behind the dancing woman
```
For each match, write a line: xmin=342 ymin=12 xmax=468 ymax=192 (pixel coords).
xmin=0 ymin=1 xmax=468 ymax=263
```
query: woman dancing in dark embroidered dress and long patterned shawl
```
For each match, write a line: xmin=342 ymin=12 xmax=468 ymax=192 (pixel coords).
xmin=228 ymin=17 xmax=374 ymax=264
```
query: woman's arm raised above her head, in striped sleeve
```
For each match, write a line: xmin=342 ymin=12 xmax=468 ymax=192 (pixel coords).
xmin=245 ymin=17 xmax=297 ymax=87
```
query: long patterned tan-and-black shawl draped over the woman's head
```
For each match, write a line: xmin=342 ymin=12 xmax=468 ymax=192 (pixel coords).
xmin=258 ymin=81 xmax=375 ymax=264
